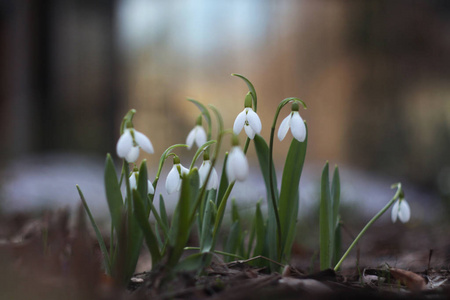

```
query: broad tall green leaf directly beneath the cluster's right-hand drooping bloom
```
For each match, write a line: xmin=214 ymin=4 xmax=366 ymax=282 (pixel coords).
xmin=278 ymin=127 xmax=308 ymax=260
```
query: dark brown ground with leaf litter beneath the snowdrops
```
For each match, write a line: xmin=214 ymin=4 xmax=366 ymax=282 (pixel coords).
xmin=0 ymin=211 xmax=450 ymax=300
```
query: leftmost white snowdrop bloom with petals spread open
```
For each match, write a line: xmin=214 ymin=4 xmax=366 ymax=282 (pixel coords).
xmin=116 ymin=128 xmax=154 ymax=162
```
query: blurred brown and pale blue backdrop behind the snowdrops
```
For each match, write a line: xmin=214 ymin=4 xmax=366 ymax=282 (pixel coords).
xmin=0 ymin=0 xmax=450 ymax=220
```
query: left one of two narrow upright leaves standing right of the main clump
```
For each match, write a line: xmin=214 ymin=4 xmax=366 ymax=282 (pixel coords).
xmin=319 ymin=162 xmax=333 ymax=270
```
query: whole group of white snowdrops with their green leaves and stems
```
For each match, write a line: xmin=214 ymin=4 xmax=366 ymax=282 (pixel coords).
xmin=77 ymin=74 xmax=410 ymax=283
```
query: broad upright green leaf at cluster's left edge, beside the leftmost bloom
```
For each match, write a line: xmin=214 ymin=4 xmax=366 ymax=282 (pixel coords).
xmin=105 ymin=154 xmax=123 ymax=232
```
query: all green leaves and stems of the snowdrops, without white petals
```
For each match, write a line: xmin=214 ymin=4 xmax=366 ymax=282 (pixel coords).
xmin=77 ymin=74 xmax=401 ymax=284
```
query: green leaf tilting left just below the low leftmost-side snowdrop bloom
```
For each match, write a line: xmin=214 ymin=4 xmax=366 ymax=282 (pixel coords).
xmin=133 ymin=190 xmax=161 ymax=266
